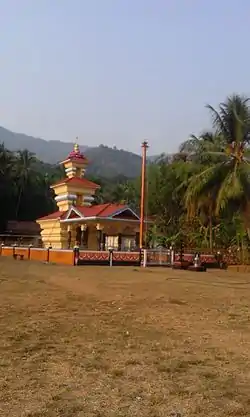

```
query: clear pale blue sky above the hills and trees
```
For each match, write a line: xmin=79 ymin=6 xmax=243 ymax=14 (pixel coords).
xmin=0 ymin=0 xmax=250 ymax=154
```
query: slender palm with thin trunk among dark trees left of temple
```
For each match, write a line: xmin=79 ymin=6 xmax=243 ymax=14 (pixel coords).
xmin=16 ymin=149 xmax=36 ymax=218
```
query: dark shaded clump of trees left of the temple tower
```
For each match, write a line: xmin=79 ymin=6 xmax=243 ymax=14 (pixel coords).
xmin=0 ymin=144 xmax=60 ymax=230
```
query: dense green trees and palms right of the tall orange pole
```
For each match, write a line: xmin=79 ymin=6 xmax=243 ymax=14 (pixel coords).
xmin=144 ymin=95 xmax=250 ymax=249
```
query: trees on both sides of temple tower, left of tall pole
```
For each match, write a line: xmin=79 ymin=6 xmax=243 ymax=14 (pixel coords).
xmin=0 ymin=144 xmax=139 ymax=231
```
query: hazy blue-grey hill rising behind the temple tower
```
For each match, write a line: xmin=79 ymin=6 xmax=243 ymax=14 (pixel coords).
xmin=0 ymin=127 xmax=141 ymax=178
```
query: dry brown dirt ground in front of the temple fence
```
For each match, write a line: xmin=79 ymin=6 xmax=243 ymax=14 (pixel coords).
xmin=0 ymin=258 xmax=250 ymax=417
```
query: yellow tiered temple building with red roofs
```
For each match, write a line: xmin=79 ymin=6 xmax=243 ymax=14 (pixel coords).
xmin=37 ymin=144 xmax=143 ymax=251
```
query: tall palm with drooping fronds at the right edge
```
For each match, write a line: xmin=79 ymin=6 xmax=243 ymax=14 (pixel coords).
xmin=185 ymin=95 xmax=250 ymax=239
